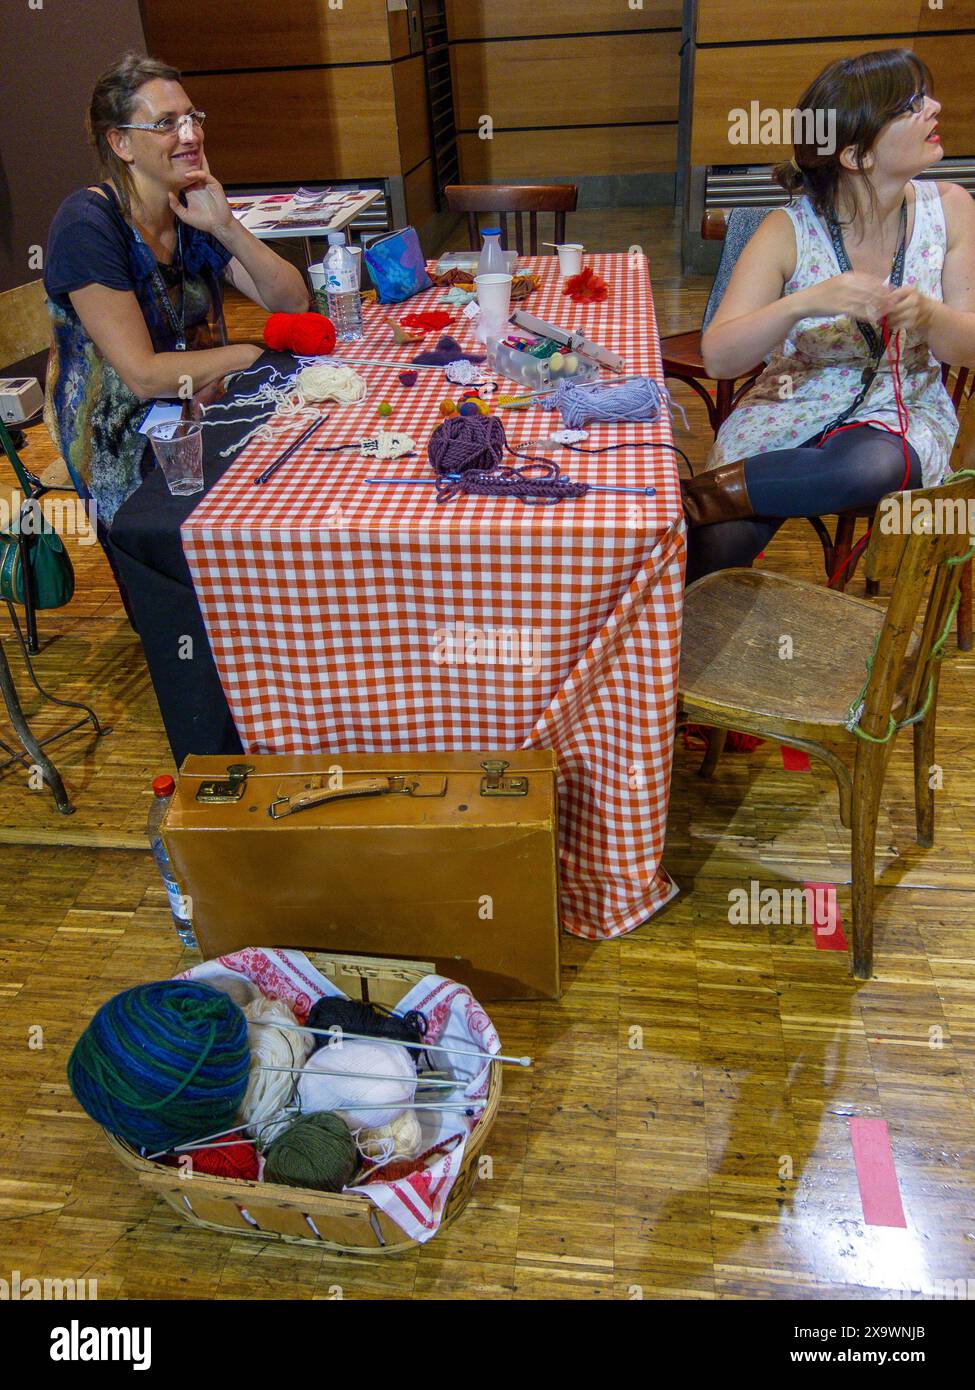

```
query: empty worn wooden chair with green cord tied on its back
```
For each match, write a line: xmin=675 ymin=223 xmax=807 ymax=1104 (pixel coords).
xmin=677 ymin=471 xmax=975 ymax=980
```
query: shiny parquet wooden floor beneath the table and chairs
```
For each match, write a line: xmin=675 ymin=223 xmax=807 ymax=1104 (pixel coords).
xmin=0 ymin=209 xmax=975 ymax=1300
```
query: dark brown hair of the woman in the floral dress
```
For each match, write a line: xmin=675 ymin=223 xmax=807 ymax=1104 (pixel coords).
xmin=772 ymin=49 xmax=933 ymax=227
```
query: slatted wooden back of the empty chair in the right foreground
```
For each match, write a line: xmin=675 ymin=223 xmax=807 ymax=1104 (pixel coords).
xmin=860 ymin=467 xmax=975 ymax=738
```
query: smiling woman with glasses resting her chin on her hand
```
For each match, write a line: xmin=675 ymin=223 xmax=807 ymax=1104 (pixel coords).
xmin=45 ymin=53 xmax=307 ymax=528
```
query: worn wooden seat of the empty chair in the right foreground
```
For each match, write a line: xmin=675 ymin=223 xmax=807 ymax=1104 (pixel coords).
xmin=679 ymin=570 xmax=918 ymax=737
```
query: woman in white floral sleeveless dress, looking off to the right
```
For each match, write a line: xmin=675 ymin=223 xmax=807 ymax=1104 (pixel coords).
xmin=682 ymin=49 xmax=975 ymax=582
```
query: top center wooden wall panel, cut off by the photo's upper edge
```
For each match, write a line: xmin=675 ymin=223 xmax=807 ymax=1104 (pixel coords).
xmin=446 ymin=0 xmax=681 ymax=42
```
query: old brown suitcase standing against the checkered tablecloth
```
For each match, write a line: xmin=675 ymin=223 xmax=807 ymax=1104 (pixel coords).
xmin=163 ymin=751 xmax=561 ymax=999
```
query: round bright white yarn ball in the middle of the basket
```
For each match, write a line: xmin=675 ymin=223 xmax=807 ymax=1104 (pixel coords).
xmin=298 ymin=1038 xmax=416 ymax=1130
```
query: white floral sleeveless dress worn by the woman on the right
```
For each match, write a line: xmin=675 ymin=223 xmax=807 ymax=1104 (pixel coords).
xmin=707 ymin=179 xmax=958 ymax=487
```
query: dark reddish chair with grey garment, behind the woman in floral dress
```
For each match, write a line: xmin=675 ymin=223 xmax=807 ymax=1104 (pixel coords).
xmin=661 ymin=207 xmax=772 ymax=434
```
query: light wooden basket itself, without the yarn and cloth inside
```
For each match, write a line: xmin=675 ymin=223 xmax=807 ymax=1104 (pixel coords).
xmin=106 ymin=951 xmax=501 ymax=1255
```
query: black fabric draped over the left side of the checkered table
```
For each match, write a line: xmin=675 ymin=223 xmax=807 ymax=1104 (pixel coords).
xmin=108 ymin=352 xmax=295 ymax=767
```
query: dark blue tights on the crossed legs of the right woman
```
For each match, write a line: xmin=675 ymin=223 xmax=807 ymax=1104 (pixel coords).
xmin=687 ymin=425 xmax=921 ymax=584
